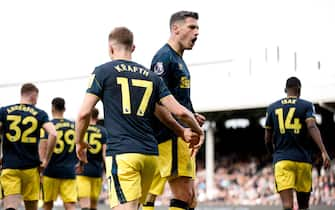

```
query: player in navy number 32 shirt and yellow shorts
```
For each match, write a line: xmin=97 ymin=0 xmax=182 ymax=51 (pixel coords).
xmin=0 ymin=83 xmax=57 ymax=210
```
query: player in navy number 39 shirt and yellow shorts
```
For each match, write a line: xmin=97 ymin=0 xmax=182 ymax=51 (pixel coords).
xmin=41 ymin=97 xmax=78 ymax=210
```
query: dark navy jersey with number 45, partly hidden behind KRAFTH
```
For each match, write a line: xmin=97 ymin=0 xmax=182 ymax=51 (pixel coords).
xmin=80 ymin=125 xmax=108 ymax=177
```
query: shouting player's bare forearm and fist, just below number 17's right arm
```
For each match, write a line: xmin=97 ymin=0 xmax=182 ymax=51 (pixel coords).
xmin=155 ymin=103 xmax=199 ymax=144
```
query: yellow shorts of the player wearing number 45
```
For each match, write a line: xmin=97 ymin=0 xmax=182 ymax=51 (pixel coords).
xmin=76 ymin=176 xmax=102 ymax=200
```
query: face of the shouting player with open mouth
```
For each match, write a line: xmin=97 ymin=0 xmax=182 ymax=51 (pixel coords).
xmin=176 ymin=17 xmax=199 ymax=50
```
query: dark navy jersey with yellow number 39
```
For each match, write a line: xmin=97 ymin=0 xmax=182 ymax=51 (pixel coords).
xmin=44 ymin=119 xmax=78 ymax=179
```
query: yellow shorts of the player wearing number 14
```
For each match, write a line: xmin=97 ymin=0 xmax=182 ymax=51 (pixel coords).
xmin=274 ymin=160 xmax=312 ymax=192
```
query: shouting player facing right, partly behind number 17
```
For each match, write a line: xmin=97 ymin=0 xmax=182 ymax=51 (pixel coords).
xmin=143 ymin=11 xmax=205 ymax=210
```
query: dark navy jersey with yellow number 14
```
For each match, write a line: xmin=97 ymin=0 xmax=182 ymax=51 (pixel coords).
xmin=265 ymin=97 xmax=315 ymax=163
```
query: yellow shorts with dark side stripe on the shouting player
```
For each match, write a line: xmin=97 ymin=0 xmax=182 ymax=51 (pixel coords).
xmin=158 ymin=137 xmax=195 ymax=179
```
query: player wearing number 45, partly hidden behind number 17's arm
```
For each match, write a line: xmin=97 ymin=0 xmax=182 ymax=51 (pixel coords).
xmin=77 ymin=108 xmax=108 ymax=210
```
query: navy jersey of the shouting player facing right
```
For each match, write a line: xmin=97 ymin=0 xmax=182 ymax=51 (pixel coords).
xmin=151 ymin=44 xmax=194 ymax=142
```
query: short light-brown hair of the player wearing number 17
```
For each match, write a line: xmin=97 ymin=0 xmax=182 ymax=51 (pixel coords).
xmin=108 ymin=27 xmax=134 ymax=49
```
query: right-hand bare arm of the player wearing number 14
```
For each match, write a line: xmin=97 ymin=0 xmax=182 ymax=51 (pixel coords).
xmin=306 ymin=118 xmax=330 ymax=169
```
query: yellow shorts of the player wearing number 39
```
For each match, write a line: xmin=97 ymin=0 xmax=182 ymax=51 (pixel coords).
xmin=43 ymin=176 xmax=77 ymax=203
